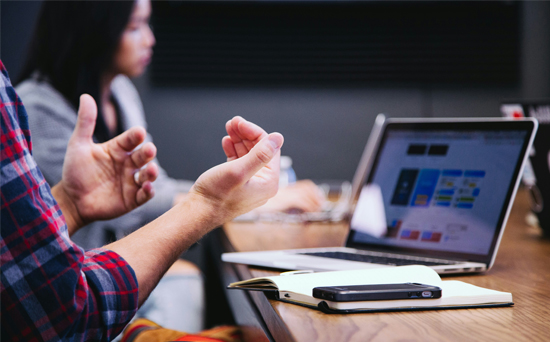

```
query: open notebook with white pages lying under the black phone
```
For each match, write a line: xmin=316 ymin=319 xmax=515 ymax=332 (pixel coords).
xmin=228 ymin=266 xmax=513 ymax=313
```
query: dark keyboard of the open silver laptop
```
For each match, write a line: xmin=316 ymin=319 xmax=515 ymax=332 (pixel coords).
xmin=300 ymin=252 xmax=458 ymax=266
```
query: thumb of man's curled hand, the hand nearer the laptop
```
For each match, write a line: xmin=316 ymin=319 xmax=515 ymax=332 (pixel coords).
xmin=233 ymin=133 xmax=284 ymax=181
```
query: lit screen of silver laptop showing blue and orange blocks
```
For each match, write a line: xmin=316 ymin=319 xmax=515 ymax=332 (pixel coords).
xmin=347 ymin=121 xmax=534 ymax=262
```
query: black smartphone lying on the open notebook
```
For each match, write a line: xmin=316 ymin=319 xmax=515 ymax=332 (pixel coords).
xmin=313 ymin=283 xmax=441 ymax=302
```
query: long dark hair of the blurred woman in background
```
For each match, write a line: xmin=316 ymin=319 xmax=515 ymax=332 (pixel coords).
xmin=17 ymin=0 xmax=134 ymax=141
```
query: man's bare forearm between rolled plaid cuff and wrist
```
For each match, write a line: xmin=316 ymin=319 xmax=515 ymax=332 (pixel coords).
xmin=105 ymin=194 xmax=223 ymax=305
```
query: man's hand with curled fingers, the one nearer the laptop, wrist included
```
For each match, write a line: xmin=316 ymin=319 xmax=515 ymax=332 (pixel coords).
xmin=190 ymin=117 xmax=283 ymax=225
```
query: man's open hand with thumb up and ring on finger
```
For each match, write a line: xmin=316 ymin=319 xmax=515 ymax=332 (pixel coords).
xmin=52 ymin=94 xmax=159 ymax=233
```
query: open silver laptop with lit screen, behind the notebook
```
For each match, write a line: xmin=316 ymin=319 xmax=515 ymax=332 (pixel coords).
xmin=222 ymin=118 xmax=538 ymax=274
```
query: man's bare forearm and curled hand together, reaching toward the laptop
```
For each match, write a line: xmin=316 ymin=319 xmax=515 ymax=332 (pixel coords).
xmin=106 ymin=117 xmax=283 ymax=303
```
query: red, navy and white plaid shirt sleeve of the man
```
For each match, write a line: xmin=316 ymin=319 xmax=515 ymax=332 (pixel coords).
xmin=0 ymin=61 xmax=138 ymax=341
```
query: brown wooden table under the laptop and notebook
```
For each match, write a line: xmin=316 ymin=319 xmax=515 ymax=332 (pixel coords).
xmin=220 ymin=192 xmax=550 ymax=342
